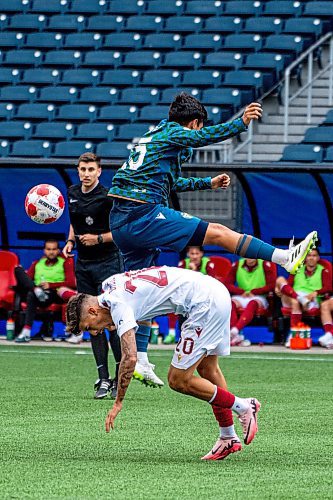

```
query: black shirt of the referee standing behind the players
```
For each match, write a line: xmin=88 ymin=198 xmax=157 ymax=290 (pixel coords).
xmin=67 ymin=183 xmax=118 ymax=261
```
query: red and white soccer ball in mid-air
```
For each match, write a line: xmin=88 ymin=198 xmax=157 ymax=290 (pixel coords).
xmin=25 ymin=184 xmax=65 ymax=224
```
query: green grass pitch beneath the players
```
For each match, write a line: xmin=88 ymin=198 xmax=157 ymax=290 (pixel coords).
xmin=0 ymin=346 xmax=333 ymax=500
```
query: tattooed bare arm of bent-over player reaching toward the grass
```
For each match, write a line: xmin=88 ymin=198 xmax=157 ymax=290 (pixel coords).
xmin=105 ymin=329 xmax=137 ymax=432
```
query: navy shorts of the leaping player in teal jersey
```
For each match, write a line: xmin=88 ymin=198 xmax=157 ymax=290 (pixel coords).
xmin=110 ymin=198 xmax=208 ymax=271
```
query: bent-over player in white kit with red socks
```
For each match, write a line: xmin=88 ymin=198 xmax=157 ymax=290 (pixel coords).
xmin=67 ymin=266 xmax=260 ymax=460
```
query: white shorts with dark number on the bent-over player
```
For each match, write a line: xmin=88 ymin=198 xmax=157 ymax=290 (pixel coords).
xmin=171 ymin=281 xmax=231 ymax=370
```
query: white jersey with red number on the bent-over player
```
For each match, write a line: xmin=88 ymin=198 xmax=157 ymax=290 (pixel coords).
xmin=98 ymin=266 xmax=226 ymax=336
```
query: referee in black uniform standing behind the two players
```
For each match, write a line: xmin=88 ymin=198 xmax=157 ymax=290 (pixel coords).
xmin=63 ymin=153 xmax=123 ymax=399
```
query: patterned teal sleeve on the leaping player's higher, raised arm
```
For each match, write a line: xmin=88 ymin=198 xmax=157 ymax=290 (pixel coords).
xmin=168 ymin=118 xmax=247 ymax=148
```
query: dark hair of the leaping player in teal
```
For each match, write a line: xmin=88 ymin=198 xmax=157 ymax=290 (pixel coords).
xmin=169 ymin=92 xmax=207 ymax=125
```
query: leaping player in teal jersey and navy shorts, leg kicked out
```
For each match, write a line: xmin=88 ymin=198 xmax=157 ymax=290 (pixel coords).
xmin=109 ymin=93 xmax=317 ymax=382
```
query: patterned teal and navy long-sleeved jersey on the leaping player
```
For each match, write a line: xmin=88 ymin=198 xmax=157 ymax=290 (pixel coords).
xmin=109 ymin=118 xmax=246 ymax=205
